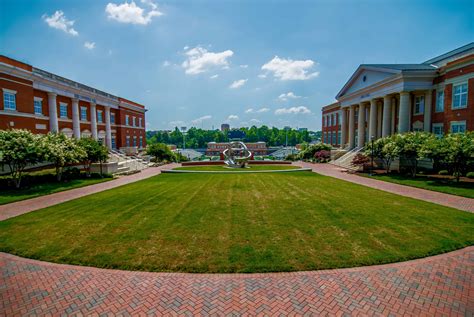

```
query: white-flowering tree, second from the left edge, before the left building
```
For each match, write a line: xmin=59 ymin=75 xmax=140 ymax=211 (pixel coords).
xmin=42 ymin=133 xmax=87 ymax=181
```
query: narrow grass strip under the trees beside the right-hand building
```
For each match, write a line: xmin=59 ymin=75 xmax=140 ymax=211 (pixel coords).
xmin=364 ymin=174 xmax=474 ymax=198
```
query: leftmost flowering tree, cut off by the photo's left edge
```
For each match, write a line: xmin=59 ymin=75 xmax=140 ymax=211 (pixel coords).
xmin=0 ymin=129 xmax=44 ymax=188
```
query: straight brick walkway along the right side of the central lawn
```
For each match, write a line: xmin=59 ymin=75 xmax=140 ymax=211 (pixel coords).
xmin=295 ymin=162 xmax=474 ymax=212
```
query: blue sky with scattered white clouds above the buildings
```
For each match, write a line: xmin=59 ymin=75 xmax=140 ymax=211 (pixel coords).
xmin=0 ymin=0 xmax=474 ymax=130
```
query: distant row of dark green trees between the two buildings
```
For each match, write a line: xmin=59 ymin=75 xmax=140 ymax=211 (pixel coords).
xmin=147 ymin=125 xmax=320 ymax=149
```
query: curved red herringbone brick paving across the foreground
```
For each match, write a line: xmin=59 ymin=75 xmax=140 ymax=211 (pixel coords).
xmin=0 ymin=247 xmax=474 ymax=316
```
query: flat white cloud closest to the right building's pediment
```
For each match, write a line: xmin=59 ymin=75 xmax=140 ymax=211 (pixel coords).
xmin=262 ymin=56 xmax=319 ymax=80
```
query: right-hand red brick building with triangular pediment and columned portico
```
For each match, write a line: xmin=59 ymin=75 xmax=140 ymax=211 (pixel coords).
xmin=322 ymin=43 xmax=474 ymax=149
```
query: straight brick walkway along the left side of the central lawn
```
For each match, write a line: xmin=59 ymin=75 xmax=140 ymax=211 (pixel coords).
xmin=0 ymin=164 xmax=178 ymax=221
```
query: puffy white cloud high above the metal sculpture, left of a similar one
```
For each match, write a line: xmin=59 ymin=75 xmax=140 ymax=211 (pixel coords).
xmin=182 ymin=46 xmax=234 ymax=75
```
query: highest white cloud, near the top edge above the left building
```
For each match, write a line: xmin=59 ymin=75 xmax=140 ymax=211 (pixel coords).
xmin=105 ymin=0 xmax=163 ymax=25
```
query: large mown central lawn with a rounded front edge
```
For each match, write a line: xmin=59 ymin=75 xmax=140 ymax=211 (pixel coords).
xmin=0 ymin=172 xmax=474 ymax=272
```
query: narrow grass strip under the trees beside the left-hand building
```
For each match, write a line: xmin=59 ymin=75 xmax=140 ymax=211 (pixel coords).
xmin=0 ymin=172 xmax=112 ymax=205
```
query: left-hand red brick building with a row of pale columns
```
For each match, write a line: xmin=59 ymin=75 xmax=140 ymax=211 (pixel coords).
xmin=0 ymin=55 xmax=146 ymax=149
